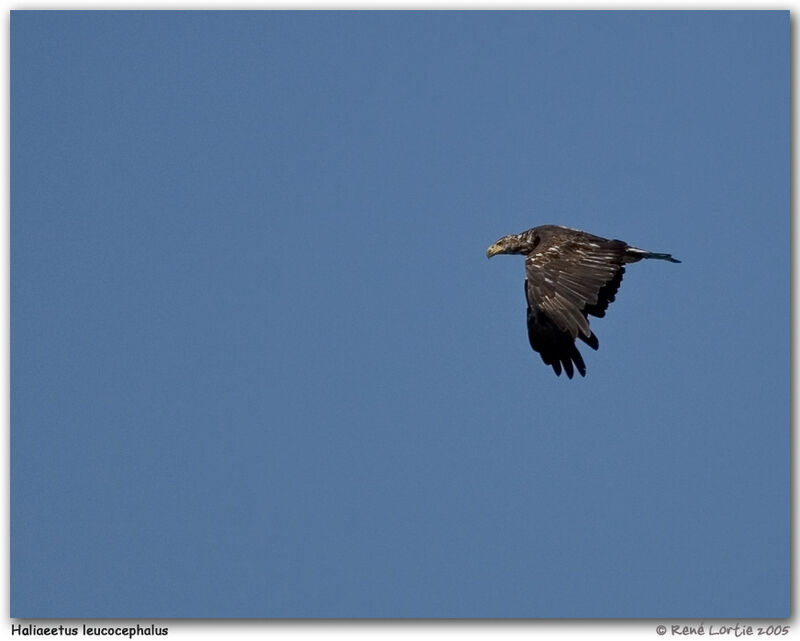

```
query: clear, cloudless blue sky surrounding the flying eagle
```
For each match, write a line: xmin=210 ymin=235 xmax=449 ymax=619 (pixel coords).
xmin=11 ymin=11 xmax=790 ymax=619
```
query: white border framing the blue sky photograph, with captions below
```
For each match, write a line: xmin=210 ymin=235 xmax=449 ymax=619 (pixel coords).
xmin=0 ymin=0 xmax=800 ymax=641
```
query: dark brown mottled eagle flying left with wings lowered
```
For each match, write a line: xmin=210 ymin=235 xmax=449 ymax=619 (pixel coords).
xmin=486 ymin=225 xmax=681 ymax=378
